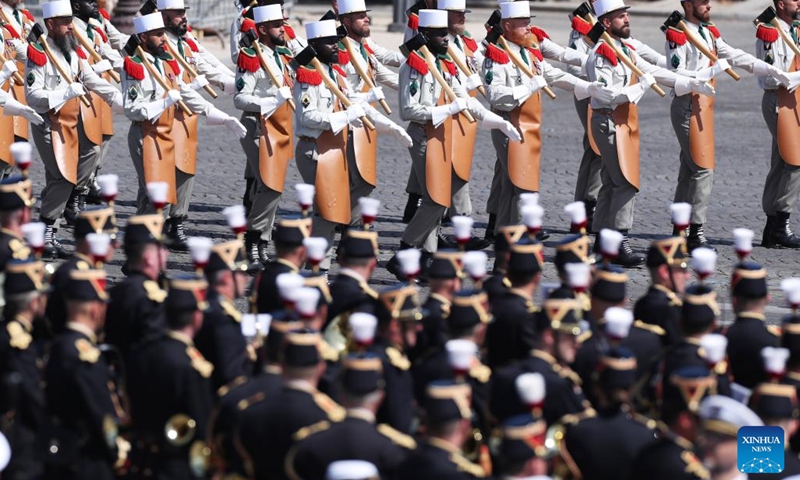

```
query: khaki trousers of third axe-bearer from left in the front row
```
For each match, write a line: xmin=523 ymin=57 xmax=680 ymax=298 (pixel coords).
xmin=239 ymin=114 xmax=281 ymax=241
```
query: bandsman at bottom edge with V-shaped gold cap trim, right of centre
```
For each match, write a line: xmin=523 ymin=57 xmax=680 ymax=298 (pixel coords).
xmin=396 ymin=381 xmax=487 ymax=480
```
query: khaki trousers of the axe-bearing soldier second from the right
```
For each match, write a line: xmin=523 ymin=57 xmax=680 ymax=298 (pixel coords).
xmin=670 ymin=95 xmax=714 ymax=224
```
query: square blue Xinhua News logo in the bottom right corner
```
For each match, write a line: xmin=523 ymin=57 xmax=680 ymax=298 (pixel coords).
xmin=737 ymin=427 xmax=785 ymax=473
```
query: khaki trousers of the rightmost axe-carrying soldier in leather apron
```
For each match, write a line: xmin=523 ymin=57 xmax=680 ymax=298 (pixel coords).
xmin=761 ymin=90 xmax=800 ymax=215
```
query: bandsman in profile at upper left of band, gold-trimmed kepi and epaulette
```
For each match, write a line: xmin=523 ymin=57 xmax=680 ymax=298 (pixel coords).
xmin=105 ymin=215 xmax=169 ymax=355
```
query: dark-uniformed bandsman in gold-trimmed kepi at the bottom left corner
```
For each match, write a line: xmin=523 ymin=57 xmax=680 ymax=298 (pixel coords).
xmin=0 ymin=259 xmax=47 ymax=480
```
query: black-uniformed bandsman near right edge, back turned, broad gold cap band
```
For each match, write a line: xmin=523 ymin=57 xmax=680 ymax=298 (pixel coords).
xmin=725 ymin=262 xmax=780 ymax=389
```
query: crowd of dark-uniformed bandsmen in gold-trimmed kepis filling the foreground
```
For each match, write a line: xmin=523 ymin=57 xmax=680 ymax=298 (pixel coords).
xmin=0 ymin=161 xmax=800 ymax=479
